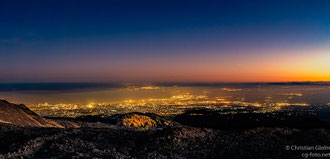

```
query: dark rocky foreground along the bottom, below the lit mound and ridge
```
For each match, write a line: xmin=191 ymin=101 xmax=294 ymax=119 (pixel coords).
xmin=0 ymin=123 xmax=330 ymax=158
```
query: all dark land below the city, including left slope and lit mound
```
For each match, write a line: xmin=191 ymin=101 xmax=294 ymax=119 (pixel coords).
xmin=0 ymin=101 xmax=330 ymax=158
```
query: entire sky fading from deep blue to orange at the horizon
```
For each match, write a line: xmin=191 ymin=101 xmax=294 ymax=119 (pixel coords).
xmin=0 ymin=0 xmax=330 ymax=82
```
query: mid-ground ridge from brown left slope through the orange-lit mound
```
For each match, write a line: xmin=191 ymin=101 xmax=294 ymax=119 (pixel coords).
xmin=0 ymin=100 xmax=177 ymax=129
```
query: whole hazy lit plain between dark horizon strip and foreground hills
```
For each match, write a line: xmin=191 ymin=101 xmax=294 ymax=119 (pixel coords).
xmin=0 ymin=84 xmax=330 ymax=117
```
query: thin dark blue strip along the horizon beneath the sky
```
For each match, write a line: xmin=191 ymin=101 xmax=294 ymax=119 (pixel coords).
xmin=0 ymin=81 xmax=330 ymax=92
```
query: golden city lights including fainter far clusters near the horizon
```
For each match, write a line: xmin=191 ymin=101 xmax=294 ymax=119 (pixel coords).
xmin=18 ymin=86 xmax=329 ymax=117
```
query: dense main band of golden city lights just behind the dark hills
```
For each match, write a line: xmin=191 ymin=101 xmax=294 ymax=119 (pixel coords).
xmin=29 ymin=99 xmax=318 ymax=117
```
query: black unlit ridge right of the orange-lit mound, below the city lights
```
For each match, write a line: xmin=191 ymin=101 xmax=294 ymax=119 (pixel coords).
xmin=174 ymin=109 xmax=330 ymax=129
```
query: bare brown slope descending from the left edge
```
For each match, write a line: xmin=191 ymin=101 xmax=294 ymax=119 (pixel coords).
xmin=0 ymin=100 xmax=61 ymax=127
